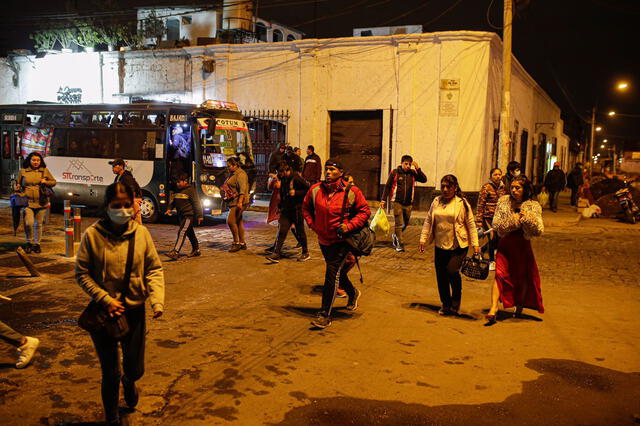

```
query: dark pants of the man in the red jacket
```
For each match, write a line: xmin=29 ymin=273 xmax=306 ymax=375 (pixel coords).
xmin=320 ymin=242 xmax=356 ymax=316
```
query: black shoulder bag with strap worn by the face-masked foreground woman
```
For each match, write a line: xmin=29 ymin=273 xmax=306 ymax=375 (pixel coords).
xmin=78 ymin=232 xmax=136 ymax=339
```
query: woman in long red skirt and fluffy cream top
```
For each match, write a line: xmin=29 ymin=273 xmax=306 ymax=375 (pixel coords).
xmin=486 ymin=176 xmax=544 ymax=324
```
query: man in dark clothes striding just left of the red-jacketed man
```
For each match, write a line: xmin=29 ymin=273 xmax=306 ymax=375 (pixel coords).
xmin=267 ymin=161 xmax=311 ymax=263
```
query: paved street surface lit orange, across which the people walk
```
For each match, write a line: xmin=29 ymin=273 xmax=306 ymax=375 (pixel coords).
xmin=0 ymin=208 xmax=640 ymax=425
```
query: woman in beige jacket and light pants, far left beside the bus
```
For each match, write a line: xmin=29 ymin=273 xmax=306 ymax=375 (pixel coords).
xmin=15 ymin=152 xmax=56 ymax=253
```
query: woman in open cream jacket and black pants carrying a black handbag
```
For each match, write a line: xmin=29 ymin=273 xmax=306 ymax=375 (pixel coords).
xmin=420 ymin=175 xmax=480 ymax=315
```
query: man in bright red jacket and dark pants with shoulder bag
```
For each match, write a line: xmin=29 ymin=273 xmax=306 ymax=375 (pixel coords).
xmin=302 ymin=159 xmax=371 ymax=328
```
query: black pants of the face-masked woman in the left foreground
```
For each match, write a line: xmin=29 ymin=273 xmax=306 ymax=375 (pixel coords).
xmin=91 ymin=305 xmax=146 ymax=422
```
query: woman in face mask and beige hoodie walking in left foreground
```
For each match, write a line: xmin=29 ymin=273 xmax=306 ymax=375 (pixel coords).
xmin=76 ymin=183 xmax=164 ymax=424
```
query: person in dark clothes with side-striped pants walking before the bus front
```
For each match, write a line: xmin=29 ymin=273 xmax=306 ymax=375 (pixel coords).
xmin=166 ymin=173 xmax=203 ymax=260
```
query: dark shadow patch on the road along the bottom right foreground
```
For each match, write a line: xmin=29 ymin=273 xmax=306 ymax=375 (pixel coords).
xmin=278 ymin=359 xmax=640 ymax=426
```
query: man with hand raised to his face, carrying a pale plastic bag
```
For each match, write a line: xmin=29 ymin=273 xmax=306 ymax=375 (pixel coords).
xmin=380 ymin=155 xmax=427 ymax=252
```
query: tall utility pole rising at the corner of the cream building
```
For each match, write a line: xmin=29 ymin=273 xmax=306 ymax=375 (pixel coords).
xmin=498 ymin=0 xmax=513 ymax=171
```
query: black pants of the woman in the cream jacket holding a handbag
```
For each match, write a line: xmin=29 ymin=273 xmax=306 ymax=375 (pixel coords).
xmin=434 ymin=247 xmax=467 ymax=310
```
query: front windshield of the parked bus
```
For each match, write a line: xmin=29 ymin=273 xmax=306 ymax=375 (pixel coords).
xmin=198 ymin=118 xmax=252 ymax=168
